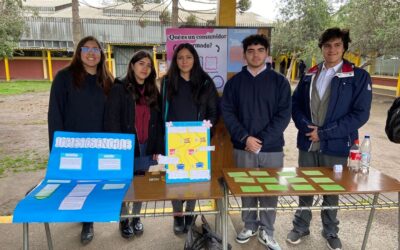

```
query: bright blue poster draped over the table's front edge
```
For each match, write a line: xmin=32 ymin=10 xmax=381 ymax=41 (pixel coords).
xmin=13 ymin=132 xmax=135 ymax=223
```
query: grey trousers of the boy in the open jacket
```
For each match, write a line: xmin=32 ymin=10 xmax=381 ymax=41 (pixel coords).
xmin=293 ymin=150 xmax=347 ymax=237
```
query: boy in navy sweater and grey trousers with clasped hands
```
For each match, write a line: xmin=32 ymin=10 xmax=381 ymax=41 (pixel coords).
xmin=221 ymin=35 xmax=291 ymax=250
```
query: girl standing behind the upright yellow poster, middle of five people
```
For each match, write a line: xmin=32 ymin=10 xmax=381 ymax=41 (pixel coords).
xmin=161 ymin=43 xmax=219 ymax=234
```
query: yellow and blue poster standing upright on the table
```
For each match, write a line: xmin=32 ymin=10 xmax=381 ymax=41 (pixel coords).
xmin=165 ymin=122 xmax=214 ymax=184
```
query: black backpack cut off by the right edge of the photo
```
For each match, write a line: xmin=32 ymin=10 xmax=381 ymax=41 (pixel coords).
xmin=385 ymin=97 xmax=400 ymax=143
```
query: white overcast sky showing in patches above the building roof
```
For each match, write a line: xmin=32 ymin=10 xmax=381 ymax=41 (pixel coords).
xmin=82 ymin=0 xmax=279 ymax=20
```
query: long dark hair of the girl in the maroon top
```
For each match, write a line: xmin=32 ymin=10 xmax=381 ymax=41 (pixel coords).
xmin=126 ymin=50 xmax=159 ymax=108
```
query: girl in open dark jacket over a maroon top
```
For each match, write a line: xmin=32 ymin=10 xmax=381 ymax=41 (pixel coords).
xmin=105 ymin=51 xmax=164 ymax=238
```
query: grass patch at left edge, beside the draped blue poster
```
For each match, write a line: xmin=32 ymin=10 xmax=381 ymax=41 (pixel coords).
xmin=0 ymin=151 xmax=47 ymax=177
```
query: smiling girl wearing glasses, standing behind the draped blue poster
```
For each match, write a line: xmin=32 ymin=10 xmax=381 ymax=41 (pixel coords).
xmin=48 ymin=36 xmax=114 ymax=244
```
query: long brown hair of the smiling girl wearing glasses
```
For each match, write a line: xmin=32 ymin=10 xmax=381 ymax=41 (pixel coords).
xmin=69 ymin=36 xmax=114 ymax=95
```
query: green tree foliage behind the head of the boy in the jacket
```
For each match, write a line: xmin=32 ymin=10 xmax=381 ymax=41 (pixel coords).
xmin=272 ymin=0 xmax=400 ymax=58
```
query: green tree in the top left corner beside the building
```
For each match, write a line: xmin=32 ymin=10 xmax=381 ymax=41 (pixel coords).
xmin=0 ymin=0 xmax=25 ymax=58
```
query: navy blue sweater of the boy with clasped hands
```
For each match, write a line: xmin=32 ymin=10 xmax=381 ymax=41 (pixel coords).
xmin=221 ymin=67 xmax=291 ymax=152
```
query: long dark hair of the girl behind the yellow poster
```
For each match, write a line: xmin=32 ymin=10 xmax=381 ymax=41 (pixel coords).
xmin=167 ymin=43 xmax=212 ymax=104
